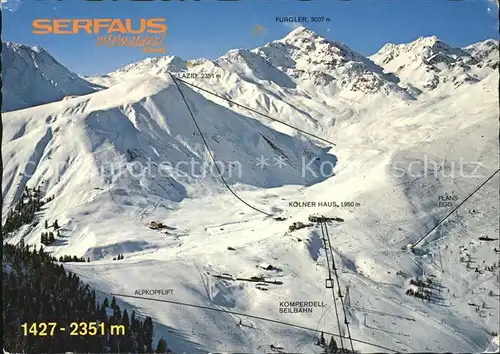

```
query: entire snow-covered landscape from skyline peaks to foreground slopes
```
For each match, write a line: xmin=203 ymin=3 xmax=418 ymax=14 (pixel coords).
xmin=2 ymin=27 xmax=500 ymax=353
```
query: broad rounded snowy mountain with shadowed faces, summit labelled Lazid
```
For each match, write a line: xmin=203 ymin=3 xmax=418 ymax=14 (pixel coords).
xmin=2 ymin=77 xmax=336 ymax=249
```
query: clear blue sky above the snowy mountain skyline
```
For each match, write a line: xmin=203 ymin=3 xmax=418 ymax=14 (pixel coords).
xmin=2 ymin=0 xmax=498 ymax=75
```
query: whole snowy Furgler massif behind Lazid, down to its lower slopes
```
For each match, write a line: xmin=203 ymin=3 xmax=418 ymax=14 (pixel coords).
xmin=87 ymin=27 xmax=430 ymax=144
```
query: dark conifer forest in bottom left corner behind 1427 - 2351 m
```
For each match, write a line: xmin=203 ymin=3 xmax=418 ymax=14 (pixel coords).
xmin=2 ymin=239 xmax=155 ymax=353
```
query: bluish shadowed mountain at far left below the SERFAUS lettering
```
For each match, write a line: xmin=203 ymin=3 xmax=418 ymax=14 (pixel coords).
xmin=2 ymin=42 xmax=99 ymax=112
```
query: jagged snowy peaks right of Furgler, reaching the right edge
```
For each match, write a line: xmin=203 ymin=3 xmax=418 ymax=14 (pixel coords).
xmin=370 ymin=36 xmax=499 ymax=92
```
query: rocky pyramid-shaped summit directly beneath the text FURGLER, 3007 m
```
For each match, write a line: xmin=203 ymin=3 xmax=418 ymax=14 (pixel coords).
xmin=252 ymin=27 xmax=411 ymax=99
